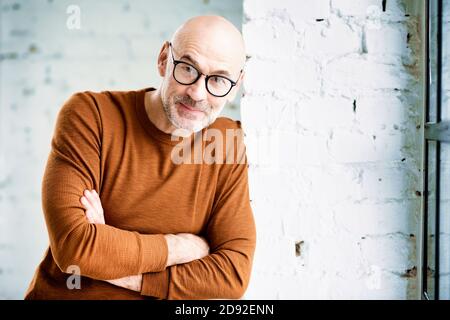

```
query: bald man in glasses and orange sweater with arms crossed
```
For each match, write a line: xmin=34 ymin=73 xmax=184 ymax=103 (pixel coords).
xmin=25 ymin=16 xmax=256 ymax=299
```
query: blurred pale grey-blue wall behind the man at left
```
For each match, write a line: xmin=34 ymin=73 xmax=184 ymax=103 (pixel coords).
xmin=0 ymin=0 xmax=242 ymax=299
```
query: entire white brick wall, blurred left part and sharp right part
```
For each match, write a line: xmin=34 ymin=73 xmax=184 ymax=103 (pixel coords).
xmin=0 ymin=0 xmax=428 ymax=299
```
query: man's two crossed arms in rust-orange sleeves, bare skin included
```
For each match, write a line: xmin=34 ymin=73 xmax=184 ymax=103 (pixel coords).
xmin=42 ymin=93 xmax=256 ymax=299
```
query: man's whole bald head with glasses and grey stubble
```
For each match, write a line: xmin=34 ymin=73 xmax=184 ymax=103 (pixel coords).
xmin=149 ymin=16 xmax=245 ymax=132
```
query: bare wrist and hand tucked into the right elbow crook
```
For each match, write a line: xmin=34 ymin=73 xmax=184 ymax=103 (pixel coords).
xmin=164 ymin=233 xmax=209 ymax=267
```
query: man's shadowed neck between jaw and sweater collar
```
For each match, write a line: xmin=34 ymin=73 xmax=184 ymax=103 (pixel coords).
xmin=144 ymin=89 xmax=176 ymax=134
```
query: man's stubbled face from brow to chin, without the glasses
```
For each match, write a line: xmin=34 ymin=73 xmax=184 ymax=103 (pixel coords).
xmin=161 ymin=42 xmax=241 ymax=132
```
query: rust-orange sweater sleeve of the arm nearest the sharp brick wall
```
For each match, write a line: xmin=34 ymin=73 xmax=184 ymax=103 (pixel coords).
xmin=141 ymin=124 xmax=256 ymax=299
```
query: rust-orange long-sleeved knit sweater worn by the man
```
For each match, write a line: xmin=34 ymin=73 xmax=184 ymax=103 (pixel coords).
xmin=25 ymin=88 xmax=256 ymax=299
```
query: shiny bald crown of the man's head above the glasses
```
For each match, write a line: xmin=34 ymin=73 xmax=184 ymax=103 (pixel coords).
xmin=171 ymin=15 xmax=245 ymax=75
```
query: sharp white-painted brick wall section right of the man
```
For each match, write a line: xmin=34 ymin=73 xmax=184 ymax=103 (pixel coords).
xmin=241 ymin=0 xmax=422 ymax=299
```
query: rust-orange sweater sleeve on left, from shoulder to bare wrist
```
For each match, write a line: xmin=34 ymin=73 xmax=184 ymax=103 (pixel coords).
xmin=42 ymin=93 xmax=168 ymax=280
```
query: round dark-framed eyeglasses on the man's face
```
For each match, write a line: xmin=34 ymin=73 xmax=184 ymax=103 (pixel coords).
xmin=169 ymin=42 xmax=242 ymax=97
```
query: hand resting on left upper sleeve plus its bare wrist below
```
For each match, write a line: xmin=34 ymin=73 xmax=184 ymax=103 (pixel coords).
xmin=80 ymin=190 xmax=142 ymax=292
